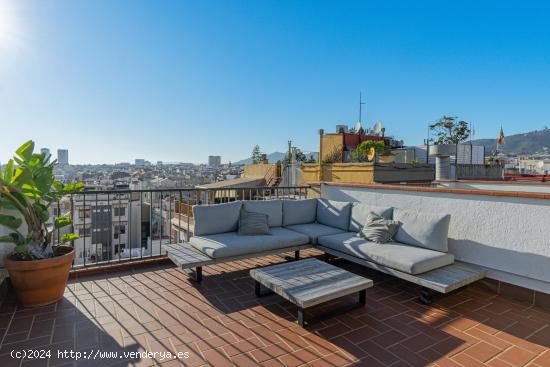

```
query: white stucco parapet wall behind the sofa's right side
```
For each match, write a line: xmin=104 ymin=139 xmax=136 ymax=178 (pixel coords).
xmin=321 ymin=185 xmax=550 ymax=293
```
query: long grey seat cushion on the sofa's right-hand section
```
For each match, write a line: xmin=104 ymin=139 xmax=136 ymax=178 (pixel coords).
xmin=318 ymin=232 xmax=454 ymax=274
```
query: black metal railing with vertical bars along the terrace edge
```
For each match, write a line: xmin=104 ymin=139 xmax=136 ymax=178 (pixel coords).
xmin=52 ymin=186 xmax=308 ymax=268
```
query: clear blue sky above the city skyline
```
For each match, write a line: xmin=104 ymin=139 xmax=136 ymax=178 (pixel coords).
xmin=0 ymin=0 xmax=550 ymax=163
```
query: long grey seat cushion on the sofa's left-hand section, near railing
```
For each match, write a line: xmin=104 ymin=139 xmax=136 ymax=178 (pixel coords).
xmin=189 ymin=227 xmax=309 ymax=259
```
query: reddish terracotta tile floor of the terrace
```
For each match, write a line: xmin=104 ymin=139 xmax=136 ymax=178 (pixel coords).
xmin=0 ymin=252 xmax=550 ymax=367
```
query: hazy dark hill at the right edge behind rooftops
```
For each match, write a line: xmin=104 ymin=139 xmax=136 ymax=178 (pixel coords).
xmin=472 ymin=129 xmax=550 ymax=155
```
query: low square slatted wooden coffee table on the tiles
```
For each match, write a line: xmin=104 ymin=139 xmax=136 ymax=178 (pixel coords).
xmin=250 ymin=258 xmax=373 ymax=326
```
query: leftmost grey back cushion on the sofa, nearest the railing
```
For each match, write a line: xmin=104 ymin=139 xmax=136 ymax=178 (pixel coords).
xmin=193 ymin=201 xmax=242 ymax=236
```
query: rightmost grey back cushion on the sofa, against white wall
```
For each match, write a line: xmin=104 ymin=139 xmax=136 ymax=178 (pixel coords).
xmin=393 ymin=208 xmax=451 ymax=252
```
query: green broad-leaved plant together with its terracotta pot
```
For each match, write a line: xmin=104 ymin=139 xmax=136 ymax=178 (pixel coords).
xmin=0 ymin=140 xmax=84 ymax=307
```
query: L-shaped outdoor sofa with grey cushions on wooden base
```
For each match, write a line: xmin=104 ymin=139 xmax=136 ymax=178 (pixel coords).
xmin=166 ymin=199 xmax=485 ymax=302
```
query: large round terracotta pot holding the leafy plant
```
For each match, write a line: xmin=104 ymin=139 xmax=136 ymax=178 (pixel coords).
xmin=4 ymin=246 xmax=74 ymax=307
